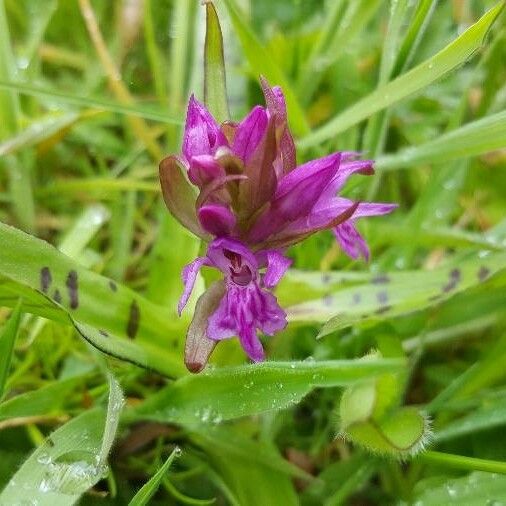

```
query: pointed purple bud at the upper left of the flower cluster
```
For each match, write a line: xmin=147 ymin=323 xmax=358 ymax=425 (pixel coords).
xmin=182 ymin=95 xmax=227 ymax=160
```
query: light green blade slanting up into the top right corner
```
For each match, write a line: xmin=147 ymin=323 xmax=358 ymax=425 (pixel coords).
xmin=298 ymin=2 xmax=504 ymax=149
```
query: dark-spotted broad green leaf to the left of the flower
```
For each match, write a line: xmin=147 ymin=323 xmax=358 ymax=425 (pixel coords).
xmin=0 ymin=224 xmax=184 ymax=376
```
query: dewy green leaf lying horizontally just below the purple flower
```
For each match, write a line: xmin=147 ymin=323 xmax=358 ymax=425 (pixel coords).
xmin=126 ymin=359 xmax=404 ymax=425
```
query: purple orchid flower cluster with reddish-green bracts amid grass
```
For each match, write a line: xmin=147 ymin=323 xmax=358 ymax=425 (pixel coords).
xmin=160 ymin=78 xmax=396 ymax=371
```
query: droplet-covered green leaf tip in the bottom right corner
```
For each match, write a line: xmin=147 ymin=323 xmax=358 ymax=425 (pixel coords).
xmin=411 ymin=472 xmax=506 ymax=506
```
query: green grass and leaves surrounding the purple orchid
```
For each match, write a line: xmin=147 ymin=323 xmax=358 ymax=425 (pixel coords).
xmin=0 ymin=0 xmax=506 ymax=506
